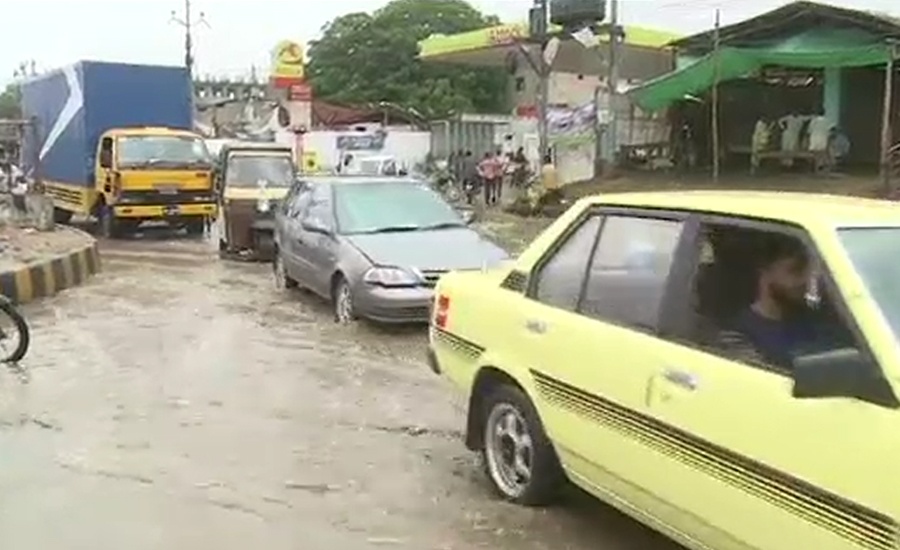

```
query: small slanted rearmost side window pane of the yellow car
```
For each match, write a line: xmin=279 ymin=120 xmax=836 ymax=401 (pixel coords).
xmin=534 ymin=216 xmax=601 ymax=311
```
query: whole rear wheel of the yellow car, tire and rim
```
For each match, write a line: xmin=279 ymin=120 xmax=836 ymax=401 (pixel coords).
xmin=482 ymin=385 xmax=565 ymax=506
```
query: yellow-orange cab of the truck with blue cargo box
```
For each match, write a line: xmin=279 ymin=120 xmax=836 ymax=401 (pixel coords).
xmin=91 ymin=128 xmax=216 ymax=237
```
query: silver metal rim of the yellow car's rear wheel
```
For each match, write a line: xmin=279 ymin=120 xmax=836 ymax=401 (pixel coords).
xmin=485 ymin=403 xmax=534 ymax=498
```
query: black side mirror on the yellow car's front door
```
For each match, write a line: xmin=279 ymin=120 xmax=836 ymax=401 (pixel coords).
xmin=793 ymin=348 xmax=900 ymax=407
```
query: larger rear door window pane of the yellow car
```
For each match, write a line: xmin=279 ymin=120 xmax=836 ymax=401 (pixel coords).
xmin=580 ymin=216 xmax=684 ymax=329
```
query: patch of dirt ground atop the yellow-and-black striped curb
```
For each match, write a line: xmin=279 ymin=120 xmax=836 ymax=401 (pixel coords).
xmin=0 ymin=225 xmax=90 ymax=270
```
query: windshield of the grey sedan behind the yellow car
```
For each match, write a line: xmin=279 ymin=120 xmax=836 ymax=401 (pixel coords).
xmin=335 ymin=182 xmax=465 ymax=233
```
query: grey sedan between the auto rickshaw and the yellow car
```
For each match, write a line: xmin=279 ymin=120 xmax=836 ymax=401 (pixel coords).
xmin=274 ymin=176 xmax=507 ymax=323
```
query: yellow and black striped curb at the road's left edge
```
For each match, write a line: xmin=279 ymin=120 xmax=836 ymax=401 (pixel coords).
xmin=0 ymin=235 xmax=100 ymax=304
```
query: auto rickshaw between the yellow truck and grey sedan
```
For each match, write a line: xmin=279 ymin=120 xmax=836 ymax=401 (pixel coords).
xmin=216 ymin=143 xmax=297 ymax=260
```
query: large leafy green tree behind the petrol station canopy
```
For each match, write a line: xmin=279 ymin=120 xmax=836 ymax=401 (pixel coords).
xmin=307 ymin=0 xmax=508 ymax=118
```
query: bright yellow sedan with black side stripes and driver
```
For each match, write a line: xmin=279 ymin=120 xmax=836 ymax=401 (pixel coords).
xmin=429 ymin=191 xmax=900 ymax=550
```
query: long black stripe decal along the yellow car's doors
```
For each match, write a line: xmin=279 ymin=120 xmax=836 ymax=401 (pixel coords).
xmin=531 ymin=370 xmax=898 ymax=550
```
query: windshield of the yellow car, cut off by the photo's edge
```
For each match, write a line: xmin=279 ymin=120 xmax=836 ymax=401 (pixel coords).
xmin=838 ymin=227 xmax=900 ymax=341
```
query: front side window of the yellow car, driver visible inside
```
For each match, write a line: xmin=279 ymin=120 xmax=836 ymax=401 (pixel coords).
xmin=677 ymin=223 xmax=862 ymax=375
